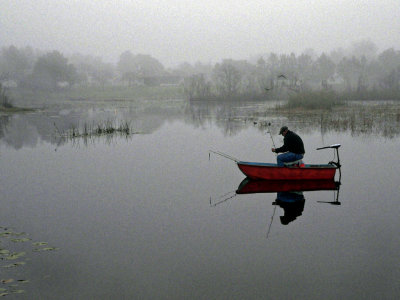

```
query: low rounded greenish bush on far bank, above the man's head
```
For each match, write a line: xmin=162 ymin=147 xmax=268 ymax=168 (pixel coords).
xmin=281 ymin=90 xmax=344 ymax=110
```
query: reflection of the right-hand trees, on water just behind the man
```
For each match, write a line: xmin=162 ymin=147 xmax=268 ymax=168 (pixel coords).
xmin=186 ymin=101 xmax=400 ymax=138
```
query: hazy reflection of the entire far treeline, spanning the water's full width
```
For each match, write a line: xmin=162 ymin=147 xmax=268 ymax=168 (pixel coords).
xmin=0 ymin=100 xmax=400 ymax=149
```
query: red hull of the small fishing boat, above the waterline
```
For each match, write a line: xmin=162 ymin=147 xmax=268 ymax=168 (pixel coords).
xmin=237 ymin=161 xmax=337 ymax=180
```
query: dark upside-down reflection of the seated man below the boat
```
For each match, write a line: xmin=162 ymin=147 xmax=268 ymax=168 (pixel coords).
xmin=272 ymin=192 xmax=305 ymax=225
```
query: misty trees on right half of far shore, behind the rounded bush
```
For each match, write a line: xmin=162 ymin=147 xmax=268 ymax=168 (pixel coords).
xmin=185 ymin=41 xmax=400 ymax=100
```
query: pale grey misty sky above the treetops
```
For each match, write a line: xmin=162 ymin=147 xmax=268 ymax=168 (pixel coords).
xmin=0 ymin=0 xmax=400 ymax=66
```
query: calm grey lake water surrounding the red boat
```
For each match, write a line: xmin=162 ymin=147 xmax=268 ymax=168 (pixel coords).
xmin=0 ymin=100 xmax=400 ymax=299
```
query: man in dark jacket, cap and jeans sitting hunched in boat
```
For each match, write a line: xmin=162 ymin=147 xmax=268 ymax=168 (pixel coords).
xmin=271 ymin=126 xmax=305 ymax=167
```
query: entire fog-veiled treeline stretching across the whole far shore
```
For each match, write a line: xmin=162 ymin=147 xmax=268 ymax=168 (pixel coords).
xmin=0 ymin=41 xmax=400 ymax=100
